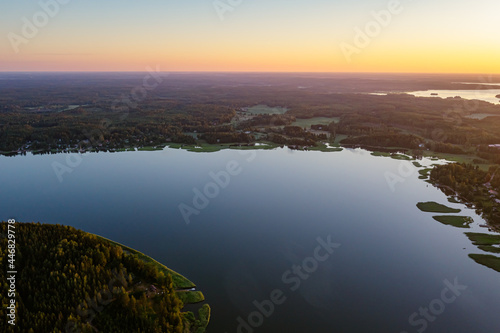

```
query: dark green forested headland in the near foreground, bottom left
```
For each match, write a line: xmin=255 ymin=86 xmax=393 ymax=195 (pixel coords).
xmin=0 ymin=222 xmax=210 ymax=333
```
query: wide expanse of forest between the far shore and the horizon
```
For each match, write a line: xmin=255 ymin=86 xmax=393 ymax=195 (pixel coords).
xmin=0 ymin=73 xmax=500 ymax=158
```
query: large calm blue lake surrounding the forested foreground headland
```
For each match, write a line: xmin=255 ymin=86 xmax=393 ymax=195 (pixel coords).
xmin=0 ymin=148 xmax=500 ymax=333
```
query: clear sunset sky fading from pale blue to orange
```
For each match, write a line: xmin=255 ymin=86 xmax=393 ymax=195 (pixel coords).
xmin=0 ymin=0 xmax=500 ymax=74
